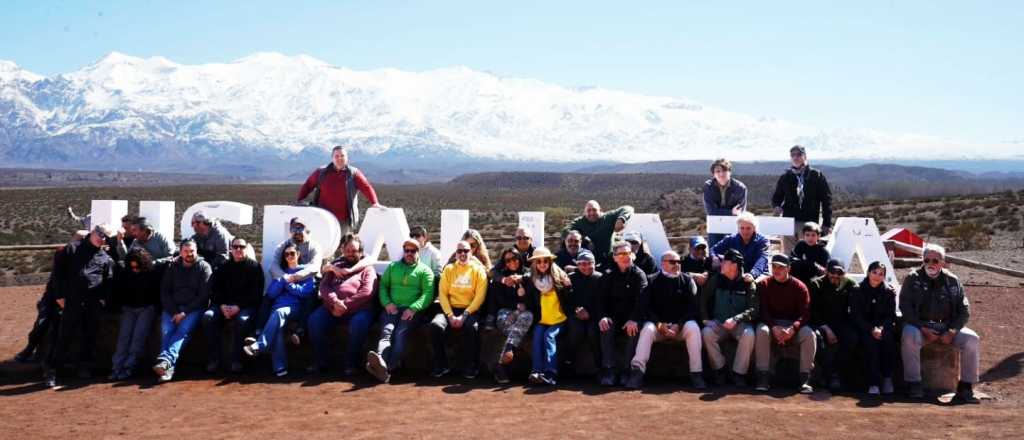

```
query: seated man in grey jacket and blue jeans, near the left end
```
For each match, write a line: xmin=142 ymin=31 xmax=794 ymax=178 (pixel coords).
xmin=153 ymin=239 xmax=213 ymax=382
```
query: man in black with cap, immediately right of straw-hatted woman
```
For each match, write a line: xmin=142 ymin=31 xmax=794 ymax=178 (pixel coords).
xmin=562 ymin=250 xmax=602 ymax=371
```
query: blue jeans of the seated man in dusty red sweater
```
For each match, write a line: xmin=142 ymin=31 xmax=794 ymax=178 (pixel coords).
xmin=307 ymin=306 xmax=374 ymax=368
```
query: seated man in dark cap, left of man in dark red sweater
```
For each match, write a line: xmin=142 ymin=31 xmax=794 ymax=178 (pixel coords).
xmin=699 ymin=249 xmax=761 ymax=388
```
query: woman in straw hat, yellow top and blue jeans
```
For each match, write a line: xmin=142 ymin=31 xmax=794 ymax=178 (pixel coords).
xmin=519 ymin=248 xmax=571 ymax=385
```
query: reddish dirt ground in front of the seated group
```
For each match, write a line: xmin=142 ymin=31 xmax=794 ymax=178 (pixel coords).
xmin=0 ymin=266 xmax=1024 ymax=439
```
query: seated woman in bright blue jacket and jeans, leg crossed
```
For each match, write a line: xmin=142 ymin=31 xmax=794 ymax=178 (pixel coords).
xmin=244 ymin=244 xmax=315 ymax=378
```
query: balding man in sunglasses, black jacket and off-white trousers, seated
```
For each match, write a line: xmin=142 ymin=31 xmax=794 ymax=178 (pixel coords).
xmin=626 ymin=251 xmax=708 ymax=390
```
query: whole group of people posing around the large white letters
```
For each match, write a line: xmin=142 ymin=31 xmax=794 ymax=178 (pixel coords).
xmin=17 ymin=145 xmax=979 ymax=403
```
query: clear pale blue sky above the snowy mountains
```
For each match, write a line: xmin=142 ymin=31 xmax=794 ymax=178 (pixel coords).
xmin=0 ymin=0 xmax=1024 ymax=143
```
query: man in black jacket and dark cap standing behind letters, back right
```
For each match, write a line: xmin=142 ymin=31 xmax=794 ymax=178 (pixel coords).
xmin=771 ymin=145 xmax=831 ymax=250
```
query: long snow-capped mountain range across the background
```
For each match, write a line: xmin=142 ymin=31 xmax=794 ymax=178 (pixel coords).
xmin=0 ymin=53 xmax=1020 ymax=173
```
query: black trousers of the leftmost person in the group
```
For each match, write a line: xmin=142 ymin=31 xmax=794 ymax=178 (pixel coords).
xmin=45 ymin=299 xmax=102 ymax=369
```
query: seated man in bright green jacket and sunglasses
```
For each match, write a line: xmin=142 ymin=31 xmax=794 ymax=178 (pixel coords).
xmin=367 ymin=239 xmax=434 ymax=383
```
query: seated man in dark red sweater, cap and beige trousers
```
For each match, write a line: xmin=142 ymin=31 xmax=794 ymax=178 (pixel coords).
xmin=755 ymin=254 xmax=817 ymax=394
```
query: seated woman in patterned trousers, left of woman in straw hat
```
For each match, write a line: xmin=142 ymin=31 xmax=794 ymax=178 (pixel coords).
xmin=485 ymin=248 xmax=534 ymax=384
